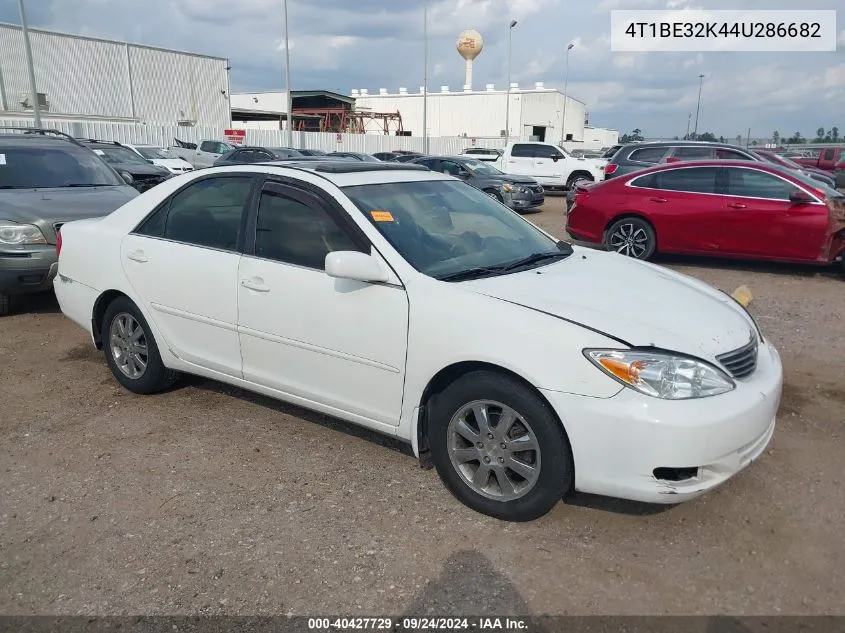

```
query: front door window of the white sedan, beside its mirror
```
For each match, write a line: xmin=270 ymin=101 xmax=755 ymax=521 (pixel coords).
xmin=255 ymin=187 xmax=361 ymax=270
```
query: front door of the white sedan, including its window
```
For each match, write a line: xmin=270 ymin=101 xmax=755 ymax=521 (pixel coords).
xmin=238 ymin=181 xmax=408 ymax=425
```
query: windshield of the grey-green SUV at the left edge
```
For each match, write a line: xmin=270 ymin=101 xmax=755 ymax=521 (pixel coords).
xmin=0 ymin=143 xmax=126 ymax=189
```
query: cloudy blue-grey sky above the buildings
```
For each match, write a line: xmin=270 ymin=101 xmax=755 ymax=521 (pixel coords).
xmin=0 ymin=0 xmax=845 ymax=138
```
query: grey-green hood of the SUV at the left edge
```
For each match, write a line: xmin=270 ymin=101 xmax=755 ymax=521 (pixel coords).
xmin=0 ymin=185 xmax=138 ymax=224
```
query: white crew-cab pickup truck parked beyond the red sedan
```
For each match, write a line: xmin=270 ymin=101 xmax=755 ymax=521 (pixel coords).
xmin=493 ymin=141 xmax=607 ymax=189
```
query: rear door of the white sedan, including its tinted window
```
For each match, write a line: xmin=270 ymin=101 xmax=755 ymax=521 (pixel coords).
xmin=121 ymin=175 xmax=254 ymax=377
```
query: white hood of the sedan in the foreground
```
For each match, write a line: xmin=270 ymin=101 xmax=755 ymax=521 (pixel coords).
xmin=461 ymin=247 xmax=754 ymax=360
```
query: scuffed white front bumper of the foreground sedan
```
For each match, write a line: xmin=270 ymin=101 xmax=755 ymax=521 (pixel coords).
xmin=543 ymin=344 xmax=783 ymax=504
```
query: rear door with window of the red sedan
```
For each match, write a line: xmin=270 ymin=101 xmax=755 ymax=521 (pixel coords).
xmin=630 ymin=166 xmax=721 ymax=253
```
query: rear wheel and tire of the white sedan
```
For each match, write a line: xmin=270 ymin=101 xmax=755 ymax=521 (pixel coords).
xmin=100 ymin=297 xmax=179 ymax=394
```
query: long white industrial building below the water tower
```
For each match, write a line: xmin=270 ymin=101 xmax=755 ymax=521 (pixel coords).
xmin=352 ymin=82 xmax=587 ymax=143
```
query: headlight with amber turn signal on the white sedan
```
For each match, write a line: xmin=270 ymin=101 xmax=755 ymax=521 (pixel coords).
xmin=584 ymin=349 xmax=736 ymax=400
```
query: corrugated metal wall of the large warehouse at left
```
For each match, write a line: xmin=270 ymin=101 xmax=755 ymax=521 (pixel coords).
xmin=0 ymin=24 xmax=229 ymax=130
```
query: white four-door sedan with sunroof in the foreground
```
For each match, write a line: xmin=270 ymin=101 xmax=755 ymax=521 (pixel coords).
xmin=55 ymin=160 xmax=782 ymax=521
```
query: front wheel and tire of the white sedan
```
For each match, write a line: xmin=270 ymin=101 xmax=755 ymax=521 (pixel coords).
xmin=429 ymin=371 xmax=574 ymax=521
